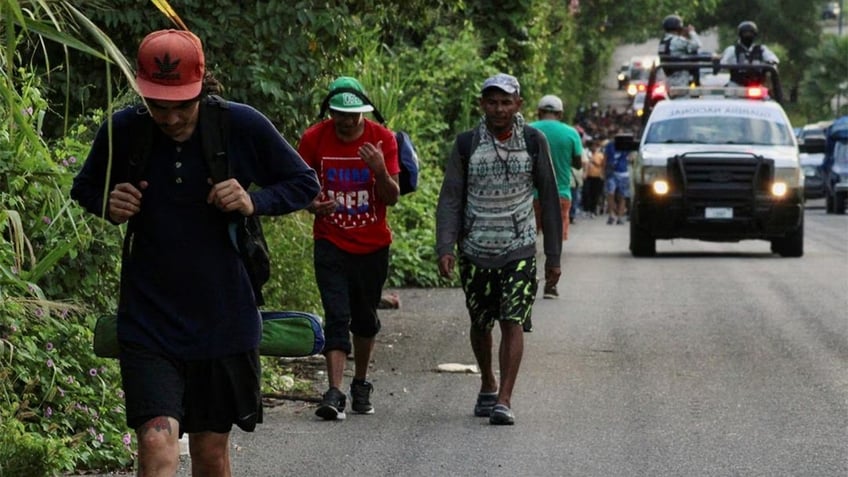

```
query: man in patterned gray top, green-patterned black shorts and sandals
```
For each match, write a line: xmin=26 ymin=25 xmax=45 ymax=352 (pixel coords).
xmin=436 ymin=73 xmax=562 ymax=425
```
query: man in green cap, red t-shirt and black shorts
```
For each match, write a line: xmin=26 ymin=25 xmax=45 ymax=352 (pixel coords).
xmin=298 ymin=76 xmax=400 ymax=420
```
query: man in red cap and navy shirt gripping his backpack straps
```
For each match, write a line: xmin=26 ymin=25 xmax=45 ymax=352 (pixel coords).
xmin=71 ymin=30 xmax=319 ymax=476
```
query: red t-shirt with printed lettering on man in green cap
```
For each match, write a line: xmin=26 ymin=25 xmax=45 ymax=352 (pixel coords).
xmin=297 ymin=118 xmax=400 ymax=253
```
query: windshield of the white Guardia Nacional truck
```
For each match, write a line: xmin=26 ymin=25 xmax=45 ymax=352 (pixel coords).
xmin=644 ymin=116 xmax=794 ymax=146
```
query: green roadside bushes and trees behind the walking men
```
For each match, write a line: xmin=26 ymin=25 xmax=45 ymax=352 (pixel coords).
xmin=0 ymin=0 xmax=848 ymax=477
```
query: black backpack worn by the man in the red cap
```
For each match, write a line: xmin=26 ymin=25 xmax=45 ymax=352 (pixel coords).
xmin=123 ymin=95 xmax=271 ymax=306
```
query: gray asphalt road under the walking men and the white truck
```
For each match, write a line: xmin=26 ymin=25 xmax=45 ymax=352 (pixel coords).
xmin=202 ymin=204 xmax=848 ymax=477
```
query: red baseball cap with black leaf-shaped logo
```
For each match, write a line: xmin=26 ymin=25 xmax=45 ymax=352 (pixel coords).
xmin=135 ymin=30 xmax=206 ymax=101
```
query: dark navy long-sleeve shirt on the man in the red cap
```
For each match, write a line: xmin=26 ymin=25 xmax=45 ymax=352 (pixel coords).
xmin=71 ymin=103 xmax=320 ymax=359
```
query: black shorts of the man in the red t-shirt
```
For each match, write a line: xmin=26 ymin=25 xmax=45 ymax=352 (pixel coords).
xmin=314 ymin=240 xmax=389 ymax=353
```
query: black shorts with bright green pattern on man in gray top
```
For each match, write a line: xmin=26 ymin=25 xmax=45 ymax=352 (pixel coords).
xmin=459 ymin=256 xmax=539 ymax=330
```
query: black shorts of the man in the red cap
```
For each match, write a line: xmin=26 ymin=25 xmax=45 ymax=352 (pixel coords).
xmin=120 ymin=342 xmax=262 ymax=435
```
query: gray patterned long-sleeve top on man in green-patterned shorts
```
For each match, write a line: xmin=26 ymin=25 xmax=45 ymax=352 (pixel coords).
xmin=436 ymin=118 xmax=562 ymax=268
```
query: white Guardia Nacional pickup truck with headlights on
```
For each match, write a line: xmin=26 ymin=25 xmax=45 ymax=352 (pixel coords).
xmin=615 ymin=58 xmax=804 ymax=257
